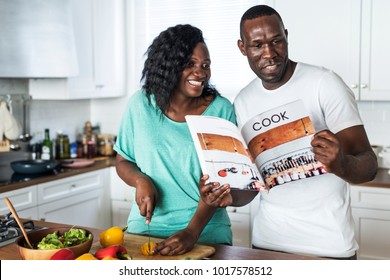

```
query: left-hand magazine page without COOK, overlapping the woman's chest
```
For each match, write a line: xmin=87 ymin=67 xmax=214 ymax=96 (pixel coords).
xmin=186 ymin=115 xmax=264 ymax=190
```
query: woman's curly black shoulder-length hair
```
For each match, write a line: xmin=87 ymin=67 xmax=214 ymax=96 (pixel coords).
xmin=141 ymin=24 xmax=219 ymax=113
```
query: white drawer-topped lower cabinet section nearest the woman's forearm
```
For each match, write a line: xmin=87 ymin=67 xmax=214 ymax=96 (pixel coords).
xmin=37 ymin=168 xmax=111 ymax=229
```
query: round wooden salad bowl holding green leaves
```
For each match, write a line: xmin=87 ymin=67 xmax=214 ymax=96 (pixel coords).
xmin=16 ymin=227 xmax=93 ymax=260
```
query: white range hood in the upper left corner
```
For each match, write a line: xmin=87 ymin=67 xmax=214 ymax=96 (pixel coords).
xmin=0 ymin=0 xmax=78 ymax=78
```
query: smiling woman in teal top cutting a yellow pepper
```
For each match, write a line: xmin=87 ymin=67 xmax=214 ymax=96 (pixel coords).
xmin=115 ymin=25 xmax=235 ymax=255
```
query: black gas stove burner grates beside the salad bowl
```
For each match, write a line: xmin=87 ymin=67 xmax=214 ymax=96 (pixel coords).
xmin=0 ymin=212 xmax=42 ymax=247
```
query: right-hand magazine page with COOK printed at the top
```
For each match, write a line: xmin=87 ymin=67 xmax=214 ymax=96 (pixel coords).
xmin=241 ymin=100 xmax=326 ymax=189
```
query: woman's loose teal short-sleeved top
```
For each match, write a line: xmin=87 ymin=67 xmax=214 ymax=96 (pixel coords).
xmin=114 ymin=90 xmax=236 ymax=244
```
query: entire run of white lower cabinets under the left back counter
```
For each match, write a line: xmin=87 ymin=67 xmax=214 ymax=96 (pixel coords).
xmin=0 ymin=168 xmax=111 ymax=229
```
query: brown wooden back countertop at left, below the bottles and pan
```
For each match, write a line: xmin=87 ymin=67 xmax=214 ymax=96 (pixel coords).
xmin=0 ymin=157 xmax=115 ymax=193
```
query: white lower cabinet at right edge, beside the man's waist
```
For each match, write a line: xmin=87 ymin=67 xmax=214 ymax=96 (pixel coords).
xmin=351 ymin=186 xmax=390 ymax=259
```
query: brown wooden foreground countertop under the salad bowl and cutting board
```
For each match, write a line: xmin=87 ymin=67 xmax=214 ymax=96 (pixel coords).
xmin=0 ymin=221 xmax=321 ymax=260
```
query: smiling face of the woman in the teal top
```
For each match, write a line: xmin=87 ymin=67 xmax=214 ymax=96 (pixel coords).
xmin=175 ymin=43 xmax=211 ymax=97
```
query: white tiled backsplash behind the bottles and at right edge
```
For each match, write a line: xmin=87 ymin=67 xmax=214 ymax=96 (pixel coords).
xmin=0 ymin=79 xmax=390 ymax=146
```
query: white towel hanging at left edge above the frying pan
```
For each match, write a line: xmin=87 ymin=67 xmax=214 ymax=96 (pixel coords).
xmin=0 ymin=102 xmax=22 ymax=141
